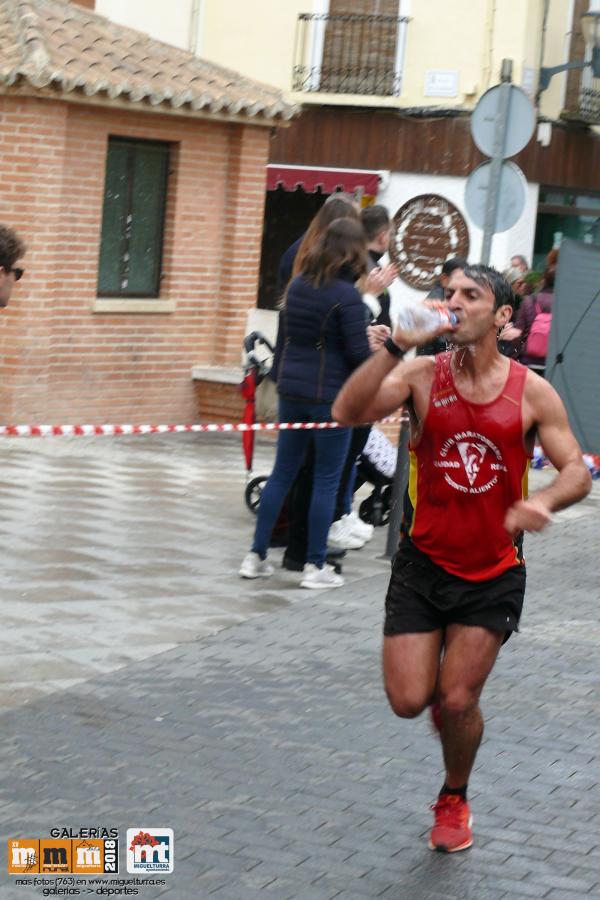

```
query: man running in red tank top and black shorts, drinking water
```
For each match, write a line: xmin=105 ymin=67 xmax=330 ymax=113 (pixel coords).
xmin=333 ymin=265 xmax=591 ymax=852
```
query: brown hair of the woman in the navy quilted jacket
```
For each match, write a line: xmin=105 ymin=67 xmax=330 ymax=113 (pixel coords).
xmin=301 ymin=219 xmax=367 ymax=287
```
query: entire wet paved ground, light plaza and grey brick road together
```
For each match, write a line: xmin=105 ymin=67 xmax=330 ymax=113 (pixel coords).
xmin=0 ymin=436 xmax=600 ymax=900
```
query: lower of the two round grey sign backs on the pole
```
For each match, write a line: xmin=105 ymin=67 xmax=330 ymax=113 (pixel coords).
xmin=465 ymin=162 xmax=526 ymax=232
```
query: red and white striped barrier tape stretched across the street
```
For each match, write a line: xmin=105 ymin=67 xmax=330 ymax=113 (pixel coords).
xmin=0 ymin=417 xmax=408 ymax=437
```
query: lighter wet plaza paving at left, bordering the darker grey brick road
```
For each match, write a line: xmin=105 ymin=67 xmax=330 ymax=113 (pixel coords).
xmin=0 ymin=435 xmax=384 ymax=710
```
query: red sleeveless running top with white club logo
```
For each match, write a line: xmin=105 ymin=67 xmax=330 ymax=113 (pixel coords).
xmin=403 ymin=353 xmax=530 ymax=581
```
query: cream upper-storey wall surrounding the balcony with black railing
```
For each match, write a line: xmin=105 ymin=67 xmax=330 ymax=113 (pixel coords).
xmin=91 ymin=0 xmax=560 ymax=116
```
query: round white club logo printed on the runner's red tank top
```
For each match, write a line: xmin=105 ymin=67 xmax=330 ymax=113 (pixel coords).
xmin=433 ymin=431 xmax=508 ymax=494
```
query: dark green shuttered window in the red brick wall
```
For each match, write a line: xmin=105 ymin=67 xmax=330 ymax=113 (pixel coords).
xmin=98 ymin=138 xmax=169 ymax=297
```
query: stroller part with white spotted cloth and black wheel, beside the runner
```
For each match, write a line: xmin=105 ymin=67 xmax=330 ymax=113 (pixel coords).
xmin=354 ymin=427 xmax=397 ymax=527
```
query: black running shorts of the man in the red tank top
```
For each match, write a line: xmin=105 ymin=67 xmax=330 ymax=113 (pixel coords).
xmin=383 ymin=538 xmax=525 ymax=641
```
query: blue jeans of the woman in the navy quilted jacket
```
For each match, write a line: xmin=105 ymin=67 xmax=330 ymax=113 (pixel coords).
xmin=252 ymin=397 xmax=351 ymax=568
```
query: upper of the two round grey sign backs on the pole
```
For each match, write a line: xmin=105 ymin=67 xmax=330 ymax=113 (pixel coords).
xmin=471 ymin=84 xmax=535 ymax=159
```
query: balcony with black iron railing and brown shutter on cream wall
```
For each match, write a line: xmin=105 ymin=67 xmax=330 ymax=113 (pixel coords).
xmin=292 ymin=13 xmax=409 ymax=97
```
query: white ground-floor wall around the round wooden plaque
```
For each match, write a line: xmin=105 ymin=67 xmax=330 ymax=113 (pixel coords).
xmin=376 ymin=172 xmax=539 ymax=319
